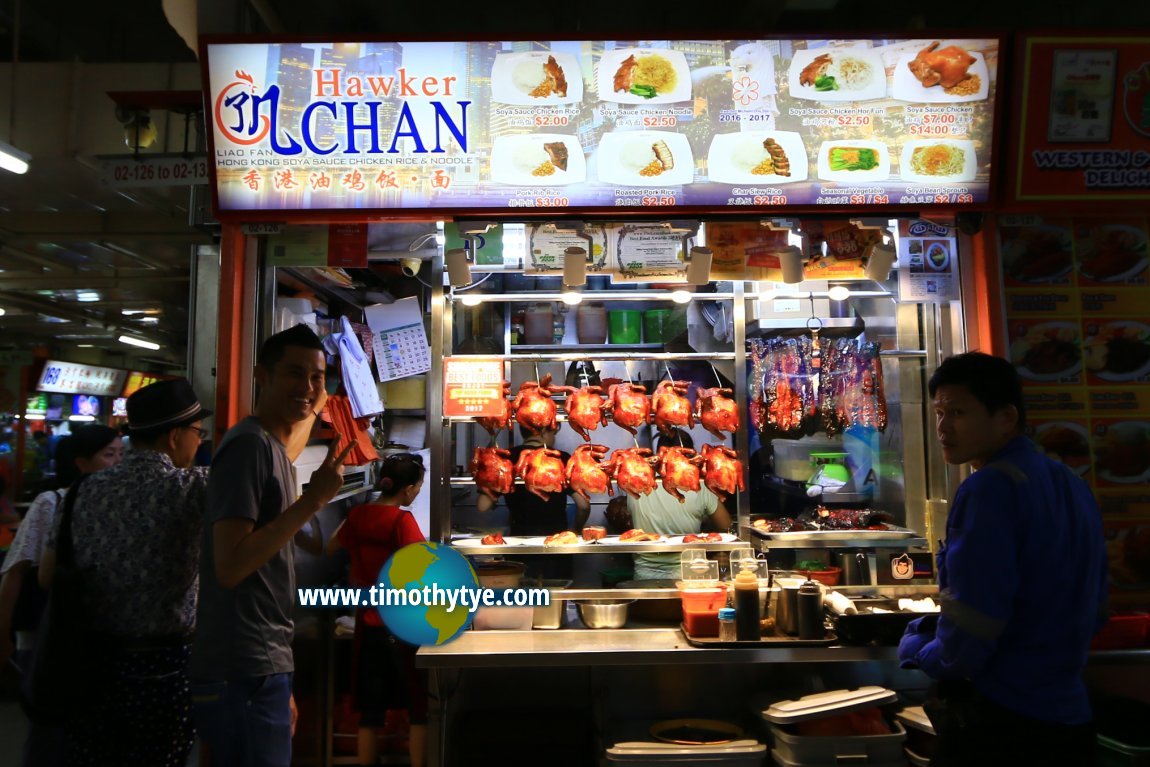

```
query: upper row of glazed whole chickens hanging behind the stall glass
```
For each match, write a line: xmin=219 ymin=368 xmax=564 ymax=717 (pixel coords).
xmin=475 ymin=374 xmax=739 ymax=442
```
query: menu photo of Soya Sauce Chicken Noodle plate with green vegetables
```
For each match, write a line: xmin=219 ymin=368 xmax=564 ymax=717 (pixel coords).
xmin=598 ymin=48 xmax=691 ymax=103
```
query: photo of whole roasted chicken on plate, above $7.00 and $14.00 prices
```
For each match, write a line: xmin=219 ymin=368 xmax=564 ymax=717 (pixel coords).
xmin=891 ymin=40 xmax=990 ymax=103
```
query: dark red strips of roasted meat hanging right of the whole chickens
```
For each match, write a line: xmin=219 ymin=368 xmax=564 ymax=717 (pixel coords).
xmin=748 ymin=333 xmax=887 ymax=438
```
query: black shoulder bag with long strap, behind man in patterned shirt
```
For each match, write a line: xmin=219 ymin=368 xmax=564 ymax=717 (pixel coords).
xmin=21 ymin=478 xmax=104 ymax=724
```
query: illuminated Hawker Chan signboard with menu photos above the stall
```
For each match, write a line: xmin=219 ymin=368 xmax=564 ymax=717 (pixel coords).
xmin=201 ymin=38 xmax=999 ymax=220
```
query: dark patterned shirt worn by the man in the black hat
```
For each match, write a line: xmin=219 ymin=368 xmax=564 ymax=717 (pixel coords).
xmin=48 ymin=450 xmax=208 ymax=637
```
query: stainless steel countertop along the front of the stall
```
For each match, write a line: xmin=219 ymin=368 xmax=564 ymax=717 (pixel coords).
xmin=415 ymin=628 xmax=898 ymax=668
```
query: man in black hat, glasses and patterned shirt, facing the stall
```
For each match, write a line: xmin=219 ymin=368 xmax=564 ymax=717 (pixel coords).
xmin=42 ymin=378 xmax=212 ymax=765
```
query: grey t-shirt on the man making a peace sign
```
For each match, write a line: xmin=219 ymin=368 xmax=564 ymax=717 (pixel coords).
xmin=191 ymin=417 xmax=296 ymax=682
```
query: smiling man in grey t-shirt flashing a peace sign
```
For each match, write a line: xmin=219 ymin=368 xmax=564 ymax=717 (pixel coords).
xmin=191 ymin=325 xmax=351 ymax=767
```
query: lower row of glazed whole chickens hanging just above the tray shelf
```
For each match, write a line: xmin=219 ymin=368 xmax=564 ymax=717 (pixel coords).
xmin=470 ymin=444 xmax=744 ymax=504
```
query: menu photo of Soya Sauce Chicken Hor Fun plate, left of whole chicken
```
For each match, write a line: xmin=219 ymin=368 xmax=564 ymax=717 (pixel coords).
xmin=787 ymin=48 xmax=887 ymax=101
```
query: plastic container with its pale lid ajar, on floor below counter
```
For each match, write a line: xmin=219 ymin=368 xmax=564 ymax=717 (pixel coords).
xmin=762 ymin=687 xmax=906 ymax=767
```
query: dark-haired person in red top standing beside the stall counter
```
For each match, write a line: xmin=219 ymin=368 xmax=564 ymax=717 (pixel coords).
xmin=328 ymin=453 xmax=428 ymax=767
